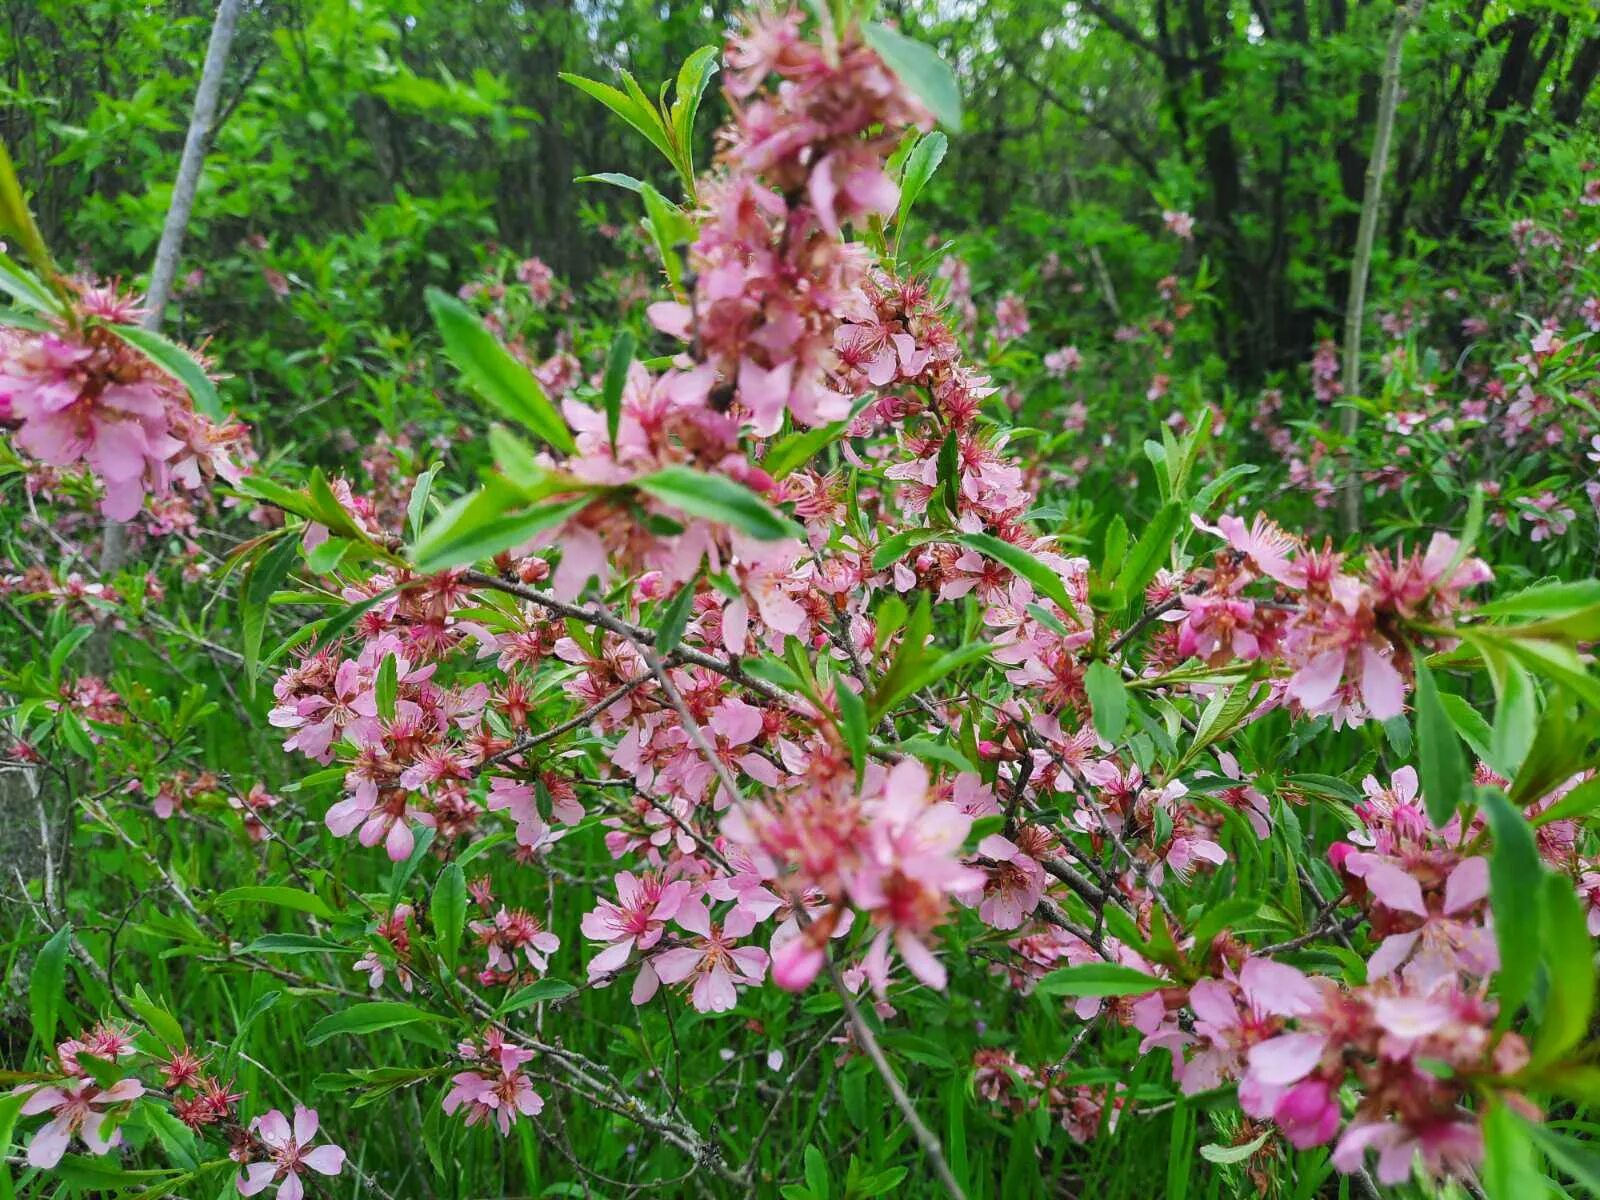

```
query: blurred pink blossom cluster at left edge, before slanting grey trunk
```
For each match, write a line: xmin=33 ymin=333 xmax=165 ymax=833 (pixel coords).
xmin=0 ymin=282 xmax=246 ymax=520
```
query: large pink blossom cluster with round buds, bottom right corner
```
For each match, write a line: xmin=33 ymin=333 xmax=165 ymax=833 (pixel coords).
xmin=1139 ymin=768 xmax=1510 ymax=1184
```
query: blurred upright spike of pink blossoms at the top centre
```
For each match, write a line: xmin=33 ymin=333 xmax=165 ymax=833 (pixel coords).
xmin=650 ymin=10 xmax=931 ymax=437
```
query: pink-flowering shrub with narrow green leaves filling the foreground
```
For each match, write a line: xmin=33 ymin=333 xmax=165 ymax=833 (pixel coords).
xmin=9 ymin=6 xmax=1600 ymax=1200
